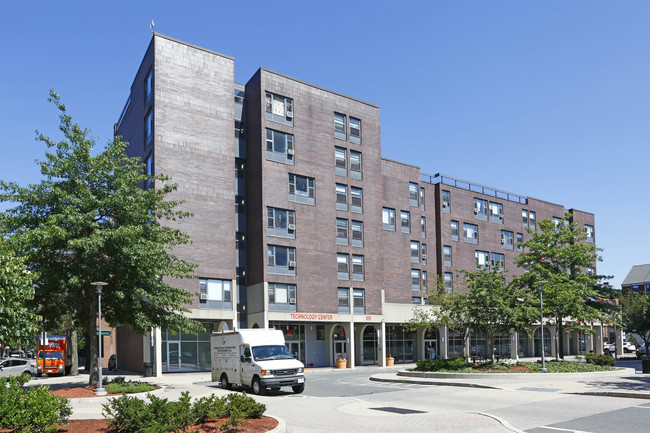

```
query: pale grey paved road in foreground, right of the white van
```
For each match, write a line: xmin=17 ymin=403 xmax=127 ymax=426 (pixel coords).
xmin=243 ymin=368 xmax=650 ymax=433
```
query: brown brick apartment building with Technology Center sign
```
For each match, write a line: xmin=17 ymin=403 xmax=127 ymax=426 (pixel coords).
xmin=115 ymin=34 xmax=595 ymax=374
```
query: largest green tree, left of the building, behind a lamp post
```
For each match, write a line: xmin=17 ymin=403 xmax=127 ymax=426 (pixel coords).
xmin=0 ymin=91 xmax=199 ymax=386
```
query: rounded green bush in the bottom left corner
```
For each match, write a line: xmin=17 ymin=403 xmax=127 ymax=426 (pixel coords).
xmin=0 ymin=375 xmax=72 ymax=433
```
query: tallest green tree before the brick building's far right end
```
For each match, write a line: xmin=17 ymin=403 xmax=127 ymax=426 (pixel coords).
xmin=513 ymin=214 xmax=607 ymax=358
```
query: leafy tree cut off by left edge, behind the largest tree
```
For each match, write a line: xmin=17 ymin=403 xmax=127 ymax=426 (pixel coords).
xmin=0 ymin=238 xmax=41 ymax=355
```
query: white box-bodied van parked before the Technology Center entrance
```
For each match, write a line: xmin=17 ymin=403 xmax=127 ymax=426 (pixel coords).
xmin=210 ymin=329 xmax=305 ymax=395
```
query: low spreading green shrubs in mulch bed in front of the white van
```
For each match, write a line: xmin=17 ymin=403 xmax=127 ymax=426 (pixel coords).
xmin=102 ymin=391 xmax=266 ymax=433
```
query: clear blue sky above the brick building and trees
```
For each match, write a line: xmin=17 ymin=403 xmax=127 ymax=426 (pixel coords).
xmin=0 ymin=0 xmax=650 ymax=286
